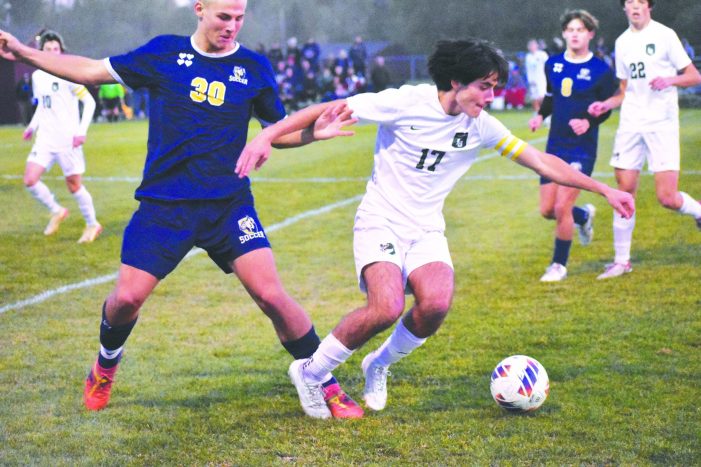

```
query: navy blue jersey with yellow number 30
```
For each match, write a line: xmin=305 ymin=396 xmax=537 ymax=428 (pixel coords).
xmin=105 ymin=35 xmax=285 ymax=201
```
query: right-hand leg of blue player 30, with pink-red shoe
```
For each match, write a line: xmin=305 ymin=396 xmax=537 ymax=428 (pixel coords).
xmin=231 ymin=248 xmax=363 ymax=418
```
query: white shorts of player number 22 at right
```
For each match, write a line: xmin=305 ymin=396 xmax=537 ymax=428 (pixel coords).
xmin=611 ymin=127 xmax=680 ymax=172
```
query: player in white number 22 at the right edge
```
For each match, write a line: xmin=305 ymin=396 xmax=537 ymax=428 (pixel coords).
xmin=589 ymin=0 xmax=701 ymax=279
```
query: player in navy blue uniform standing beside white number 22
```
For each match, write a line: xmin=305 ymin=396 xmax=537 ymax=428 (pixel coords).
xmin=529 ymin=10 xmax=615 ymax=282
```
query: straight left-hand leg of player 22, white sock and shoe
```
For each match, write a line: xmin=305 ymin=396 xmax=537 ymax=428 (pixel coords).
xmin=597 ymin=168 xmax=640 ymax=279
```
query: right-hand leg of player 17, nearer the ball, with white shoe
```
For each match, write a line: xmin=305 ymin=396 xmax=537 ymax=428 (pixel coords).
xmin=362 ymin=262 xmax=455 ymax=410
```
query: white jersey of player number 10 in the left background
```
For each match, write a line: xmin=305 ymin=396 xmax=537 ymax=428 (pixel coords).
xmin=29 ymin=70 xmax=95 ymax=151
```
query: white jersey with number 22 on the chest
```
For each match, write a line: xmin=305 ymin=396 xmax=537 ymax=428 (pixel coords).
xmin=616 ymin=21 xmax=691 ymax=132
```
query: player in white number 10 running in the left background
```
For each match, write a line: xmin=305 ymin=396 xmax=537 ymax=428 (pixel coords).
xmin=23 ymin=31 xmax=102 ymax=243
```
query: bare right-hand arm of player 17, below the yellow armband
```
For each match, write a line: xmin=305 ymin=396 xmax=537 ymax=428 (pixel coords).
xmin=516 ymin=145 xmax=635 ymax=219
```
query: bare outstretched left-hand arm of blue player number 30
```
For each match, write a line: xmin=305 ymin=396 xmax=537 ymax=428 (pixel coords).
xmin=0 ymin=30 xmax=116 ymax=84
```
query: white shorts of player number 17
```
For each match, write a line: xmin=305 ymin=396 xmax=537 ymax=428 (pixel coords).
xmin=353 ymin=213 xmax=453 ymax=294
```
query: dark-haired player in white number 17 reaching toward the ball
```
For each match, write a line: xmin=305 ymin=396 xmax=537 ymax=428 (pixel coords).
xmin=236 ymin=40 xmax=634 ymax=410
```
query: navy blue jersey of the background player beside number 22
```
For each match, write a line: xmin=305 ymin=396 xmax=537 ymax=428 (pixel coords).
xmin=545 ymin=53 xmax=615 ymax=158
